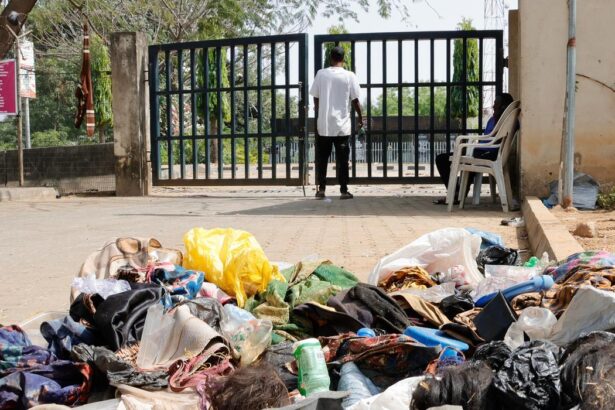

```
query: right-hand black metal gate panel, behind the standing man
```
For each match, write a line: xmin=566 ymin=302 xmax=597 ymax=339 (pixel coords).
xmin=316 ymin=31 xmax=503 ymax=183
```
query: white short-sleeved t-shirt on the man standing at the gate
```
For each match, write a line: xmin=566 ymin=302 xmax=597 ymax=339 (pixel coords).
xmin=310 ymin=67 xmax=361 ymax=137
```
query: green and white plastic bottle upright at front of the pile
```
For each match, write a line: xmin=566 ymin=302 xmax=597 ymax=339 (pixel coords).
xmin=293 ymin=339 xmax=331 ymax=397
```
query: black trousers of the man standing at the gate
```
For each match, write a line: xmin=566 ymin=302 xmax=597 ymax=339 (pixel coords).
xmin=316 ymin=136 xmax=350 ymax=193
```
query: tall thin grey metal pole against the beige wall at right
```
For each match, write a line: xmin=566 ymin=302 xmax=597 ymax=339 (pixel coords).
xmin=560 ymin=0 xmax=577 ymax=208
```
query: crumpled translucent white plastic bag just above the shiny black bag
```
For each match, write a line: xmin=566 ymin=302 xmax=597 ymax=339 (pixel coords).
xmin=504 ymin=306 xmax=557 ymax=350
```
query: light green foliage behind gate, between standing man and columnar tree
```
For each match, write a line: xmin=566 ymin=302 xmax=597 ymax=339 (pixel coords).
xmin=370 ymin=87 xmax=446 ymax=118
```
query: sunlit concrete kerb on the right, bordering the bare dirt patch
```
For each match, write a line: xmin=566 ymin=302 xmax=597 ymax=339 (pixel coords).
xmin=521 ymin=196 xmax=583 ymax=261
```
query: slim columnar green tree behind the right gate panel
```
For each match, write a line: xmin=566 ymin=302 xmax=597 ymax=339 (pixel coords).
xmin=451 ymin=18 xmax=480 ymax=118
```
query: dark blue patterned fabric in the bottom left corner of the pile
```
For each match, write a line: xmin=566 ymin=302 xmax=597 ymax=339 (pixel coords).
xmin=0 ymin=326 xmax=92 ymax=410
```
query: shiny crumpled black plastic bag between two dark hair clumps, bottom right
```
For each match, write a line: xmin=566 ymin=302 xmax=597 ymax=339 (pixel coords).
xmin=493 ymin=340 xmax=561 ymax=410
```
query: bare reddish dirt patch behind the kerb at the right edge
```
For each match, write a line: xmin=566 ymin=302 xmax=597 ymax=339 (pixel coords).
xmin=551 ymin=207 xmax=615 ymax=253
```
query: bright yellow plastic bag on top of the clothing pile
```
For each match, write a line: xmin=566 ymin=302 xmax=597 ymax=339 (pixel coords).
xmin=184 ymin=228 xmax=285 ymax=307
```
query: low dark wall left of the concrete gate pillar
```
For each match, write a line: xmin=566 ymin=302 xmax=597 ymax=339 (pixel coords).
xmin=0 ymin=144 xmax=115 ymax=195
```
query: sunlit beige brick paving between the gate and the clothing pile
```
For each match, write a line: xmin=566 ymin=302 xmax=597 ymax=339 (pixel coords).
xmin=0 ymin=186 xmax=525 ymax=323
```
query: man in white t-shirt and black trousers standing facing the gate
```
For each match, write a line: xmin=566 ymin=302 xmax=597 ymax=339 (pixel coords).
xmin=310 ymin=47 xmax=363 ymax=199
